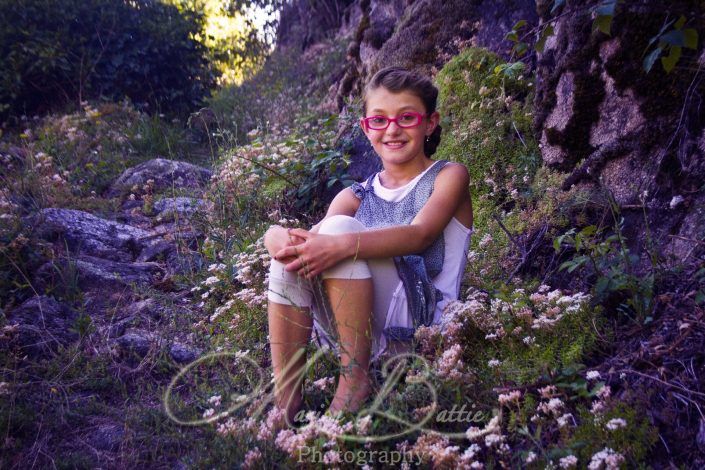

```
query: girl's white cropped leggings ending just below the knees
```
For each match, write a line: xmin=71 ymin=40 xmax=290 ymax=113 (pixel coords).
xmin=267 ymin=215 xmax=413 ymax=359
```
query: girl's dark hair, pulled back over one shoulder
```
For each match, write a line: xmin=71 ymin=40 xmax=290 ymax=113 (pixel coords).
xmin=362 ymin=67 xmax=442 ymax=157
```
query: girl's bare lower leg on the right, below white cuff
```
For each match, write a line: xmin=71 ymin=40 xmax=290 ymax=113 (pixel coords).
xmin=324 ymin=278 xmax=373 ymax=414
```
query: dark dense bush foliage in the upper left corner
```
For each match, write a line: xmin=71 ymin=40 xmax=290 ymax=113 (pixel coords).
xmin=0 ymin=0 xmax=215 ymax=117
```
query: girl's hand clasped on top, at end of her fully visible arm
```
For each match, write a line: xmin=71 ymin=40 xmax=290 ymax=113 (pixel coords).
xmin=274 ymin=228 xmax=356 ymax=279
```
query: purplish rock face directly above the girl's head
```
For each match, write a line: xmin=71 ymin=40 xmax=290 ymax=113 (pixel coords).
xmin=331 ymin=0 xmax=538 ymax=109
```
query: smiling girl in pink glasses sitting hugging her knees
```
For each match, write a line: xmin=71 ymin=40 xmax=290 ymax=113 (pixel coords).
xmin=264 ymin=67 xmax=472 ymax=422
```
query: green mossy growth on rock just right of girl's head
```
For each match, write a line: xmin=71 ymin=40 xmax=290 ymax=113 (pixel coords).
xmin=435 ymin=48 xmax=541 ymax=233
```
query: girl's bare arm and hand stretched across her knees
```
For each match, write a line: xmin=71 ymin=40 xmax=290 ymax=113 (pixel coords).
xmin=275 ymin=164 xmax=470 ymax=278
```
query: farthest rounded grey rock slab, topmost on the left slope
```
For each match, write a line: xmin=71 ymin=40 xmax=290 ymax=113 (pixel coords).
xmin=108 ymin=158 xmax=211 ymax=197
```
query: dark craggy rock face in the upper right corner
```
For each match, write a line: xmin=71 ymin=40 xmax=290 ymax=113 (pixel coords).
xmin=534 ymin=0 xmax=705 ymax=262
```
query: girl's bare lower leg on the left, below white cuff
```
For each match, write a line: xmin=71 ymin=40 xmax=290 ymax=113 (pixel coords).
xmin=267 ymin=301 xmax=313 ymax=424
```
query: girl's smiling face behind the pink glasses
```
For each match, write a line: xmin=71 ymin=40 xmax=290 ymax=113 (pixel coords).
xmin=360 ymin=87 xmax=438 ymax=166
